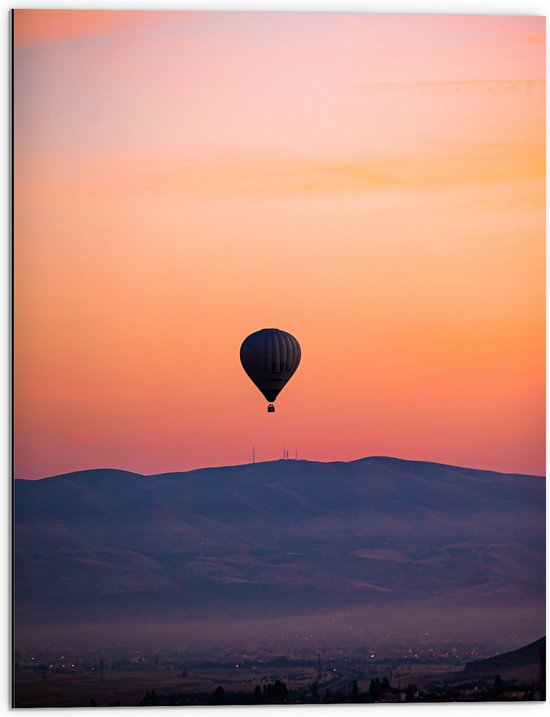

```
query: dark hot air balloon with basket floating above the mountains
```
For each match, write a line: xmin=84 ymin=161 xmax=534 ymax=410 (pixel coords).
xmin=241 ymin=329 xmax=302 ymax=413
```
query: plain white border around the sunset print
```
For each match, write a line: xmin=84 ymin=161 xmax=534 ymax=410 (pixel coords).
xmin=5 ymin=0 xmax=550 ymax=717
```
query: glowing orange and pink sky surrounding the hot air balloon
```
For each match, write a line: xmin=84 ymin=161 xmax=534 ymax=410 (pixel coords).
xmin=14 ymin=10 xmax=545 ymax=478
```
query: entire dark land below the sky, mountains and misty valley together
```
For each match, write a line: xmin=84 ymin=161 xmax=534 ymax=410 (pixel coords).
xmin=15 ymin=457 xmax=545 ymax=706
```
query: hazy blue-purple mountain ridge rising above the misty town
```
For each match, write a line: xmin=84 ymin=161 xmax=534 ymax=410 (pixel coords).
xmin=15 ymin=457 xmax=545 ymax=644
